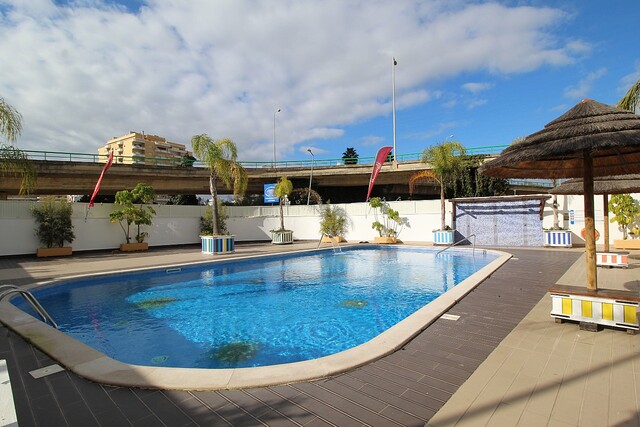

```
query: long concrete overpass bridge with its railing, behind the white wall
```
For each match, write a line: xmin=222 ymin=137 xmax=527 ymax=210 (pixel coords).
xmin=0 ymin=146 xmax=546 ymax=203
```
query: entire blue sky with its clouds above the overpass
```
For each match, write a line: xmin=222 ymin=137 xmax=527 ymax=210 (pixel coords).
xmin=0 ymin=0 xmax=640 ymax=161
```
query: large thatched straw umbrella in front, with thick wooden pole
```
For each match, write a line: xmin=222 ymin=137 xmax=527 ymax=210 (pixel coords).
xmin=481 ymin=99 xmax=640 ymax=291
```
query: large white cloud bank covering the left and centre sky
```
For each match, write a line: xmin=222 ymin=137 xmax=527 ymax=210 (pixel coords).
xmin=0 ymin=0 xmax=588 ymax=160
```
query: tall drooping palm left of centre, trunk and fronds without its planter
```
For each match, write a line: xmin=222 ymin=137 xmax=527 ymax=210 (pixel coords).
xmin=191 ymin=133 xmax=248 ymax=235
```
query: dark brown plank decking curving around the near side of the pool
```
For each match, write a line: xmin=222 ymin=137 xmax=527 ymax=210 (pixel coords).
xmin=0 ymin=249 xmax=581 ymax=427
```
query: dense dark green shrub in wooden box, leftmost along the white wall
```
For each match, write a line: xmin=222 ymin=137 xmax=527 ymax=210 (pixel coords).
xmin=31 ymin=197 xmax=76 ymax=257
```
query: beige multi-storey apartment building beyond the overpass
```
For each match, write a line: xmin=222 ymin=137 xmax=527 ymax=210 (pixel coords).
xmin=98 ymin=131 xmax=192 ymax=166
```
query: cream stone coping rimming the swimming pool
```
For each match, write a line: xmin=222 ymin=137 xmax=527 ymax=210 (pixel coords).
xmin=0 ymin=245 xmax=512 ymax=390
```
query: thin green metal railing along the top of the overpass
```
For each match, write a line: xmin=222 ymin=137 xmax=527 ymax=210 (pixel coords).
xmin=22 ymin=145 xmax=508 ymax=169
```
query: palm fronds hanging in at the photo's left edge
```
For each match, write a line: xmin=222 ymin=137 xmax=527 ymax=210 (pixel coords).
xmin=0 ymin=98 xmax=36 ymax=195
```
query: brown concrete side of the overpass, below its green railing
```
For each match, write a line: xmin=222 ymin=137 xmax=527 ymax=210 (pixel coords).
xmin=0 ymin=160 xmax=438 ymax=199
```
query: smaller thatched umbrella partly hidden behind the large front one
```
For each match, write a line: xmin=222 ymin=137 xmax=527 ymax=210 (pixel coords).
xmin=549 ymin=174 xmax=640 ymax=252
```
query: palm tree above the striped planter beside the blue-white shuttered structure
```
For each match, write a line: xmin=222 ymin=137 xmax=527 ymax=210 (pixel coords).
xmin=409 ymin=141 xmax=466 ymax=230
